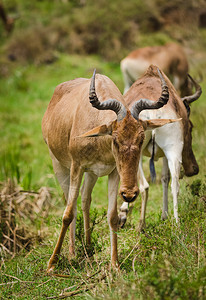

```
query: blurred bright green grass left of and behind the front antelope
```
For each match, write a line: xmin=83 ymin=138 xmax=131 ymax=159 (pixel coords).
xmin=0 ymin=55 xmax=123 ymax=185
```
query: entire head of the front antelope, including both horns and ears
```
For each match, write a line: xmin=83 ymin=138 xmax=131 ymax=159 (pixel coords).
xmin=82 ymin=69 xmax=173 ymax=202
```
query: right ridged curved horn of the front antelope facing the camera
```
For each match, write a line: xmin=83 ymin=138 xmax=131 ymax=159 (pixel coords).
xmin=131 ymin=68 xmax=169 ymax=120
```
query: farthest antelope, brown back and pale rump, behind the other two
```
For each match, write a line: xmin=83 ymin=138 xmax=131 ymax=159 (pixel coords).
xmin=120 ymin=43 xmax=191 ymax=96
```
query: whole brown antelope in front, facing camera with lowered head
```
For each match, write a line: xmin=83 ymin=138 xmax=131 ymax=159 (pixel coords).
xmin=42 ymin=68 xmax=177 ymax=272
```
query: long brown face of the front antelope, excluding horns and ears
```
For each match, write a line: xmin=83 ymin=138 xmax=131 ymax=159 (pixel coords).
xmin=112 ymin=113 xmax=145 ymax=202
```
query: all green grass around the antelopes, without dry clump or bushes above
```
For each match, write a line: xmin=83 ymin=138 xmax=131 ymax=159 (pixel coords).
xmin=0 ymin=54 xmax=206 ymax=299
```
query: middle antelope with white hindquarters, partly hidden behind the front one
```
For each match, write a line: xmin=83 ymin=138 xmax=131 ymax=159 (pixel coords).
xmin=120 ymin=66 xmax=201 ymax=230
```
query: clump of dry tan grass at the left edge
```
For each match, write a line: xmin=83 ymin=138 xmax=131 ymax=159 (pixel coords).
xmin=0 ymin=179 xmax=51 ymax=258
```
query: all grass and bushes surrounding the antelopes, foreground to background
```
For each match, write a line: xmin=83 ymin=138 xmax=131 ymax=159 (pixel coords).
xmin=0 ymin=0 xmax=206 ymax=299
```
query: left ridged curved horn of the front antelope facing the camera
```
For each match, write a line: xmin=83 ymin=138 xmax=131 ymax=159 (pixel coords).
xmin=89 ymin=70 xmax=127 ymax=121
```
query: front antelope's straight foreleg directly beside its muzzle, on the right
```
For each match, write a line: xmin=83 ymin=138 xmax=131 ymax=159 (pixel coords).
xmin=107 ymin=169 xmax=119 ymax=268
